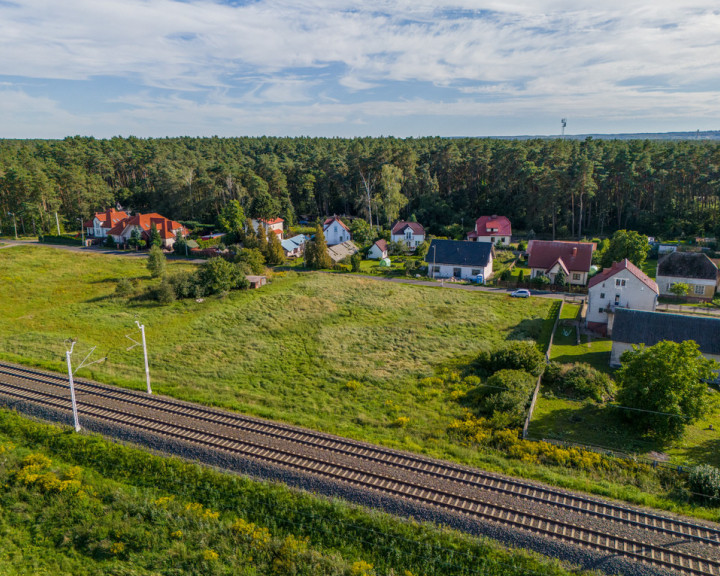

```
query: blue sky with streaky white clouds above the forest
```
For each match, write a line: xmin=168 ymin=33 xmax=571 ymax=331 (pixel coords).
xmin=0 ymin=0 xmax=720 ymax=138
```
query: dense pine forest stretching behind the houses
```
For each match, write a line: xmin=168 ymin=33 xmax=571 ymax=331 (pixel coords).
xmin=0 ymin=137 xmax=720 ymax=238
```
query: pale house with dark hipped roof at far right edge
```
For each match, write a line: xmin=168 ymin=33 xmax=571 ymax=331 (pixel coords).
xmin=655 ymin=252 xmax=718 ymax=301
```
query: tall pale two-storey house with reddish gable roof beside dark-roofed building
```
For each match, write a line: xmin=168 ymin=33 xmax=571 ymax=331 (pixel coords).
xmin=585 ymin=258 xmax=660 ymax=334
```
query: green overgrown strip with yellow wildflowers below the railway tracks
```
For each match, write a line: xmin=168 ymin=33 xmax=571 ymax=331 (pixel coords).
xmin=0 ymin=409 xmax=578 ymax=576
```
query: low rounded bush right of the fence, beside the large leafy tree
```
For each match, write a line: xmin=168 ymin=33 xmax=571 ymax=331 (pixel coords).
xmin=543 ymin=362 xmax=615 ymax=402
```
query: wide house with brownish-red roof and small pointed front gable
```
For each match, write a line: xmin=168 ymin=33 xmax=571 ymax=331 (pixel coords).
xmin=528 ymin=240 xmax=597 ymax=286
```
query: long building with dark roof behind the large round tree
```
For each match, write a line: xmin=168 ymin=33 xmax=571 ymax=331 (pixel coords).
xmin=610 ymin=308 xmax=720 ymax=366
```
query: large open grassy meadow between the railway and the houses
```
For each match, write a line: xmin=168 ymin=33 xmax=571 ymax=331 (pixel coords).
xmin=0 ymin=247 xmax=552 ymax=458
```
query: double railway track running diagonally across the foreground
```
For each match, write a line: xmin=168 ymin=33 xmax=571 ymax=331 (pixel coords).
xmin=0 ymin=362 xmax=720 ymax=576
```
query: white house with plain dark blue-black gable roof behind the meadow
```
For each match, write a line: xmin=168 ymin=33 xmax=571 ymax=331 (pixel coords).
xmin=425 ymin=240 xmax=495 ymax=283
